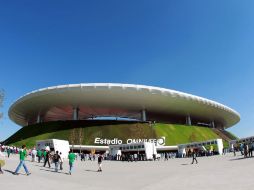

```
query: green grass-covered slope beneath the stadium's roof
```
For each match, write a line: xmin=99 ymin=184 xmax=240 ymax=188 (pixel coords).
xmin=2 ymin=121 xmax=237 ymax=147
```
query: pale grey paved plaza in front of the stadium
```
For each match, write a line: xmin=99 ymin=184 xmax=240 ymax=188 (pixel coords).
xmin=0 ymin=154 xmax=254 ymax=190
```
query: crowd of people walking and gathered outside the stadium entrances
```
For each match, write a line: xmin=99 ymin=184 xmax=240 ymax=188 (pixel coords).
xmin=0 ymin=142 xmax=254 ymax=175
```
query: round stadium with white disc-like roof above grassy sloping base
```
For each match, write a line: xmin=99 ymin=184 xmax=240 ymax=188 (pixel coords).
xmin=4 ymin=83 xmax=240 ymax=146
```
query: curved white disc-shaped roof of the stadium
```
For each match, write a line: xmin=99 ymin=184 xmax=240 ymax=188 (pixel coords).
xmin=9 ymin=83 xmax=240 ymax=127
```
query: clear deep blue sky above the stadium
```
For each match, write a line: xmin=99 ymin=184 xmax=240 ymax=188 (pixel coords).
xmin=0 ymin=0 xmax=254 ymax=140
